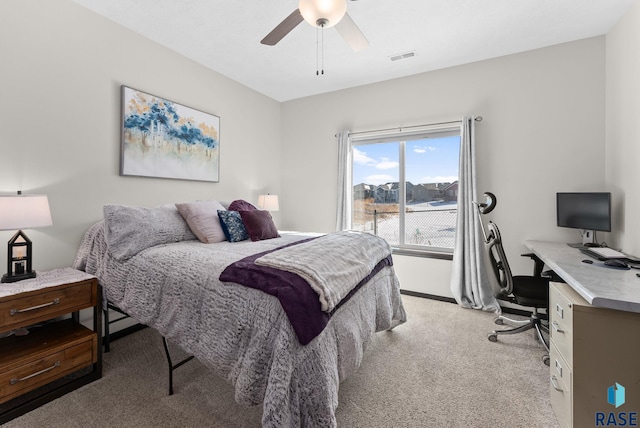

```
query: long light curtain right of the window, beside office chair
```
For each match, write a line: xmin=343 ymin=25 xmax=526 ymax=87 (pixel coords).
xmin=451 ymin=116 xmax=500 ymax=313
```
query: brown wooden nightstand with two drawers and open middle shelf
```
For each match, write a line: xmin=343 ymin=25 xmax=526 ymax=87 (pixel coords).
xmin=0 ymin=268 xmax=102 ymax=424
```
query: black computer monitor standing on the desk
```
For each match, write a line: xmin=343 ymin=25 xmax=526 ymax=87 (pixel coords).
xmin=556 ymin=192 xmax=611 ymax=246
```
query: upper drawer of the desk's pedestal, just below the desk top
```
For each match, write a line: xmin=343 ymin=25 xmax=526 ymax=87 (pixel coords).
xmin=549 ymin=283 xmax=573 ymax=365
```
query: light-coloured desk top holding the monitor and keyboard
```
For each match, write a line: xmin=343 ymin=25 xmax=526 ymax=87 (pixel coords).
xmin=524 ymin=241 xmax=640 ymax=312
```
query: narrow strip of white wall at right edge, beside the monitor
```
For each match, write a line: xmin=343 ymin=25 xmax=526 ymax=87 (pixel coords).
xmin=606 ymin=3 xmax=640 ymax=256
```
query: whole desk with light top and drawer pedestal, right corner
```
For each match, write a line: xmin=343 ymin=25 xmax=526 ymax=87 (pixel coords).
xmin=525 ymin=241 xmax=640 ymax=428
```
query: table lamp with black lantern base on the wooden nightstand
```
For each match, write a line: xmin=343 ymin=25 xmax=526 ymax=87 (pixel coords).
xmin=0 ymin=191 xmax=53 ymax=282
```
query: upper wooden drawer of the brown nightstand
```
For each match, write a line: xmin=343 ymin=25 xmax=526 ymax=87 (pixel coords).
xmin=0 ymin=280 xmax=96 ymax=332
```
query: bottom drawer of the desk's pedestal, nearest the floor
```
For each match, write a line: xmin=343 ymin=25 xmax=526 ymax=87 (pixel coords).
xmin=549 ymin=344 xmax=573 ymax=428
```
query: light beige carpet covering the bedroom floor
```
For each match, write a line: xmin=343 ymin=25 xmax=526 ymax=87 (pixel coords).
xmin=5 ymin=296 xmax=558 ymax=428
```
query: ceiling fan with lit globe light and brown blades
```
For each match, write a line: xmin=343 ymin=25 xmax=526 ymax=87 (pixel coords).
xmin=260 ymin=0 xmax=369 ymax=52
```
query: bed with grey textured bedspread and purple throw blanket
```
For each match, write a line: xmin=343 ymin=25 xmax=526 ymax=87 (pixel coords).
xmin=74 ymin=205 xmax=406 ymax=427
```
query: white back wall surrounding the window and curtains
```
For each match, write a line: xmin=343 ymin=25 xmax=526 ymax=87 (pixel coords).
xmin=281 ymin=37 xmax=607 ymax=295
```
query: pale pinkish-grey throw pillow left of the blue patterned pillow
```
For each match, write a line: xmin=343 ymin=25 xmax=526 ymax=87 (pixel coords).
xmin=176 ymin=201 xmax=226 ymax=244
